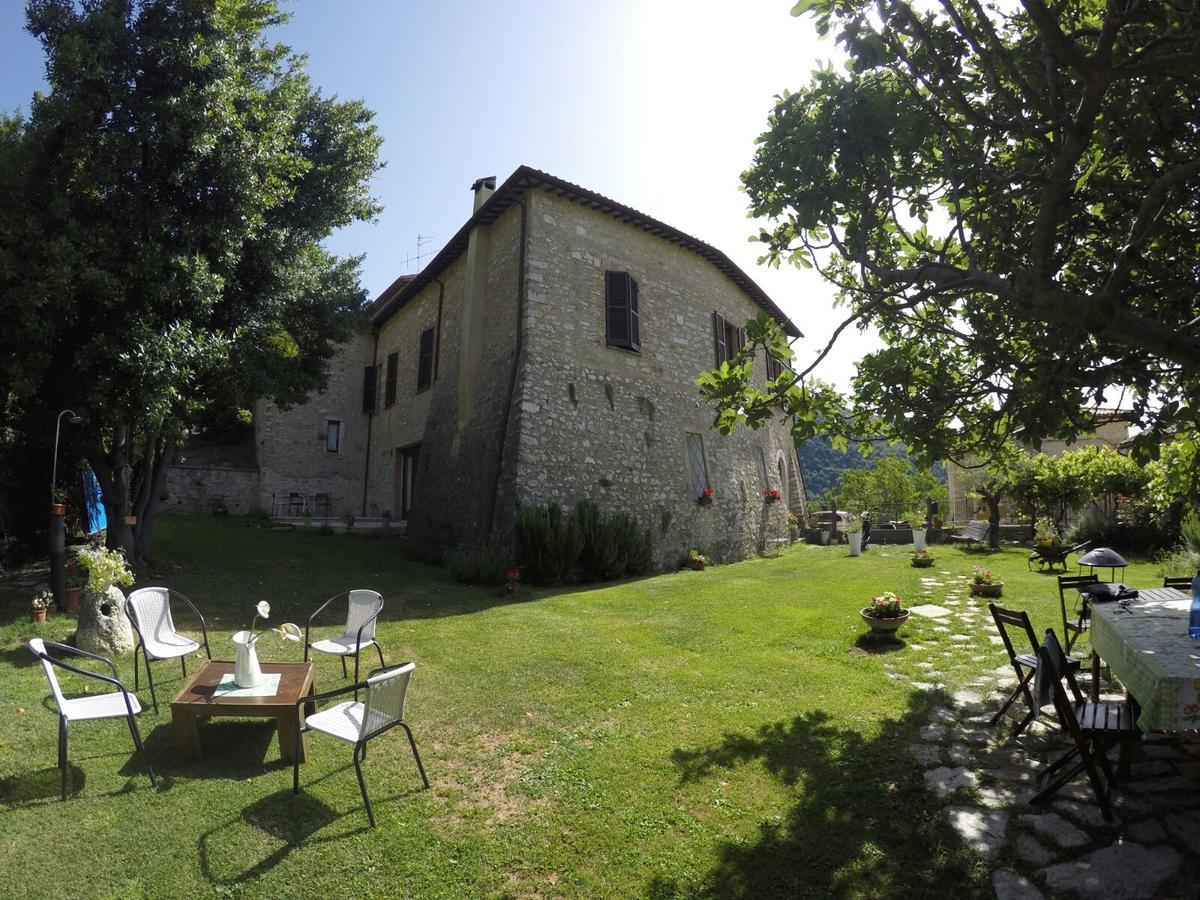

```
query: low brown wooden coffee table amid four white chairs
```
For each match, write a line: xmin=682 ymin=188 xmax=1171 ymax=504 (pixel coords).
xmin=170 ymin=660 xmax=317 ymax=762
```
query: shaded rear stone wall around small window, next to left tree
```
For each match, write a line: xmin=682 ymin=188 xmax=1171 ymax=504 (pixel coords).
xmin=254 ymin=334 xmax=374 ymax=517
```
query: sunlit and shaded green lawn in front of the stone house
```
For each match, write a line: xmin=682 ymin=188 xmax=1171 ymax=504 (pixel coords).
xmin=0 ymin=518 xmax=1158 ymax=898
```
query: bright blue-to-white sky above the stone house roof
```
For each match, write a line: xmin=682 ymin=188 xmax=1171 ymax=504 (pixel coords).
xmin=0 ymin=0 xmax=869 ymax=382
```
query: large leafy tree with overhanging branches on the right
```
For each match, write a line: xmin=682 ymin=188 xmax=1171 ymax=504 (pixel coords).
xmin=701 ymin=0 xmax=1200 ymax=472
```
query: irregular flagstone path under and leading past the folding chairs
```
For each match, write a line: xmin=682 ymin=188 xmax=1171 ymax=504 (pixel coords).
xmin=886 ymin=572 xmax=1200 ymax=900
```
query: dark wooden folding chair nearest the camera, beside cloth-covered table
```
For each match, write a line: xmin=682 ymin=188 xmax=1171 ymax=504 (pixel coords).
xmin=1030 ymin=629 xmax=1141 ymax=822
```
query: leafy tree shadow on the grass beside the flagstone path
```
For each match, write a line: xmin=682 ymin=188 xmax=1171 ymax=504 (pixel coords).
xmin=647 ymin=695 xmax=990 ymax=900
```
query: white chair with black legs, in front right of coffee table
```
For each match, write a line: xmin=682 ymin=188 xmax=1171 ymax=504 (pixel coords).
xmin=292 ymin=662 xmax=430 ymax=828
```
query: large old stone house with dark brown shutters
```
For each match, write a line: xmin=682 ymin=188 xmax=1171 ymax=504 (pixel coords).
xmin=256 ymin=167 xmax=805 ymax=566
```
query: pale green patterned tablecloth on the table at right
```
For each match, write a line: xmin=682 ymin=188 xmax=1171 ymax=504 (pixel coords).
xmin=1092 ymin=588 xmax=1200 ymax=731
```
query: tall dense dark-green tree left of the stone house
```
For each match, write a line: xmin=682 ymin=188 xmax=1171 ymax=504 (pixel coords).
xmin=0 ymin=0 xmax=380 ymax=559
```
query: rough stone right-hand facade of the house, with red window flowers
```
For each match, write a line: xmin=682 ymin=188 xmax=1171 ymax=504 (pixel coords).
xmin=516 ymin=191 xmax=805 ymax=568
